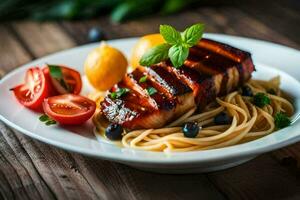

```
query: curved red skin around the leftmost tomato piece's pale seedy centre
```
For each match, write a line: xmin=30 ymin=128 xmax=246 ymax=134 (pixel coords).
xmin=12 ymin=67 xmax=49 ymax=112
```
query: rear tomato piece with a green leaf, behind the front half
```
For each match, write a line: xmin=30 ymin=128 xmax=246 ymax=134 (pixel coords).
xmin=43 ymin=65 xmax=82 ymax=94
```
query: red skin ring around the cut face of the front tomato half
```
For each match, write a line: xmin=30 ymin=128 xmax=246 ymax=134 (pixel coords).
xmin=43 ymin=94 xmax=96 ymax=125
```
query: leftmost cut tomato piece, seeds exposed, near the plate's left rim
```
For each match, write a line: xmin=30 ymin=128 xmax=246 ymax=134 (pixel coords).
xmin=12 ymin=67 xmax=49 ymax=110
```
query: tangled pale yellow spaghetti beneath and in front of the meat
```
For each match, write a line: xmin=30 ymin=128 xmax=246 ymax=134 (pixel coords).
xmin=93 ymin=77 xmax=294 ymax=152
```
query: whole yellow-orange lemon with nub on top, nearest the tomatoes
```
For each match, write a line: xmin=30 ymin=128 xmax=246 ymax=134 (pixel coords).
xmin=84 ymin=42 xmax=128 ymax=91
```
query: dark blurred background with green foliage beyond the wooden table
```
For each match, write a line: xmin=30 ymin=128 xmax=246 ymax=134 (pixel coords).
xmin=0 ymin=0 xmax=300 ymax=46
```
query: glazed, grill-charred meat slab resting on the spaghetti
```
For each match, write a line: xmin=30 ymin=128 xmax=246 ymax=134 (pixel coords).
xmin=101 ymin=39 xmax=255 ymax=129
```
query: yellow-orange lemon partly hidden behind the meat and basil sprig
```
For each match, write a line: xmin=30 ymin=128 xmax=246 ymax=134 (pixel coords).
xmin=130 ymin=33 xmax=165 ymax=69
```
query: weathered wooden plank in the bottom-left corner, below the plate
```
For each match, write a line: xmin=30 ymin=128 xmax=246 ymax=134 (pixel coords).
xmin=0 ymin=122 xmax=54 ymax=199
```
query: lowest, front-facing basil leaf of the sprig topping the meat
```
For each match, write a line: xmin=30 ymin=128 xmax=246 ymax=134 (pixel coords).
xmin=169 ymin=45 xmax=189 ymax=68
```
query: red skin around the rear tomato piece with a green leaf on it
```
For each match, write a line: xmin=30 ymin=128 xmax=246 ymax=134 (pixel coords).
xmin=43 ymin=65 xmax=82 ymax=96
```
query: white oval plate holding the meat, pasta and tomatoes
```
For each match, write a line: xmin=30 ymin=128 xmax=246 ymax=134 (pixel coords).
xmin=0 ymin=34 xmax=300 ymax=173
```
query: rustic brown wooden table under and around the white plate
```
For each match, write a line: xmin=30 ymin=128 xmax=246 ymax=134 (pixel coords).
xmin=0 ymin=0 xmax=300 ymax=200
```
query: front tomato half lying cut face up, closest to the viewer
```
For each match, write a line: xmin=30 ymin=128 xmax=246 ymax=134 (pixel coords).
xmin=43 ymin=94 xmax=96 ymax=124
